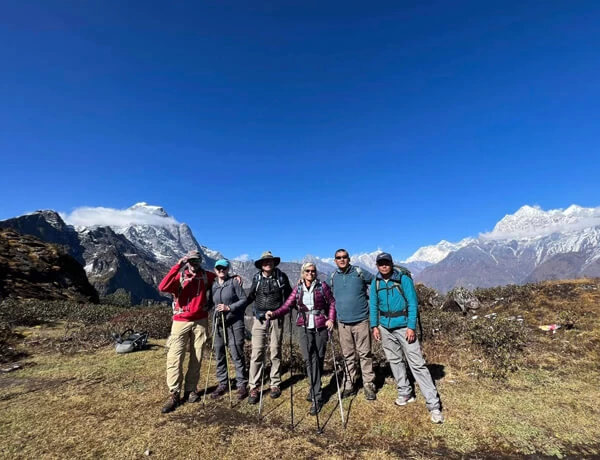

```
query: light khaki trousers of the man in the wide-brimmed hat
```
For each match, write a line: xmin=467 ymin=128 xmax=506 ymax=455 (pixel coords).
xmin=250 ymin=318 xmax=283 ymax=389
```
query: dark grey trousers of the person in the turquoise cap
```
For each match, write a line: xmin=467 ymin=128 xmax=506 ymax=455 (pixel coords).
xmin=215 ymin=317 xmax=248 ymax=388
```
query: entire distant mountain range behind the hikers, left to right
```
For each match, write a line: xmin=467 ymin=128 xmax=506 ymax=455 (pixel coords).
xmin=0 ymin=203 xmax=600 ymax=302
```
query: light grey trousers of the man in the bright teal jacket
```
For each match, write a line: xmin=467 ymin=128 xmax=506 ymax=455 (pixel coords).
xmin=379 ymin=326 xmax=441 ymax=411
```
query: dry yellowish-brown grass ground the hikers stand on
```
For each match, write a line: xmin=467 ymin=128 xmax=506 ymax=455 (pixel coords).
xmin=0 ymin=281 xmax=600 ymax=460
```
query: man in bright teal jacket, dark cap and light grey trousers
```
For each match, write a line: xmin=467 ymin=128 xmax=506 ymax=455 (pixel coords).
xmin=369 ymin=252 xmax=444 ymax=423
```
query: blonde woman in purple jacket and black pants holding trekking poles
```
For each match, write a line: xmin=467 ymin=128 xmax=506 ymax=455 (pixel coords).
xmin=266 ymin=262 xmax=335 ymax=415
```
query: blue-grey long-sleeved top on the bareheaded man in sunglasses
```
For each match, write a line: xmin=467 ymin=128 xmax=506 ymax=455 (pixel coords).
xmin=330 ymin=265 xmax=373 ymax=324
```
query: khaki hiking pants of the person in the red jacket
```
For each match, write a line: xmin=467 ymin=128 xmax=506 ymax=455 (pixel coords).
xmin=167 ymin=318 xmax=208 ymax=393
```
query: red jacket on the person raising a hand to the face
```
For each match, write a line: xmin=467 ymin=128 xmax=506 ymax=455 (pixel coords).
xmin=158 ymin=264 xmax=217 ymax=321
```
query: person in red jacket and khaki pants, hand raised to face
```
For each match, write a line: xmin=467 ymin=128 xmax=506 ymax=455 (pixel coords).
xmin=158 ymin=251 xmax=216 ymax=414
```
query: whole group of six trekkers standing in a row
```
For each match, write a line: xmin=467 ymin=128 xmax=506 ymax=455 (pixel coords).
xmin=159 ymin=249 xmax=444 ymax=425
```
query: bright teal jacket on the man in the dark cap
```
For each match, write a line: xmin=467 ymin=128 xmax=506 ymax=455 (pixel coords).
xmin=369 ymin=269 xmax=419 ymax=331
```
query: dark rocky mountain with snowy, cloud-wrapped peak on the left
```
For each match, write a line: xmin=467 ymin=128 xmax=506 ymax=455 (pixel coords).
xmin=0 ymin=203 xmax=222 ymax=302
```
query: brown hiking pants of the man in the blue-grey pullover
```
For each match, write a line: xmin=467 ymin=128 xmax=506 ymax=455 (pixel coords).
xmin=338 ymin=319 xmax=375 ymax=390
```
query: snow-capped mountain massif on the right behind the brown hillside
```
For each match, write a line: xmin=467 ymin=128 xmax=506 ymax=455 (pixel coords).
xmin=415 ymin=205 xmax=600 ymax=292
